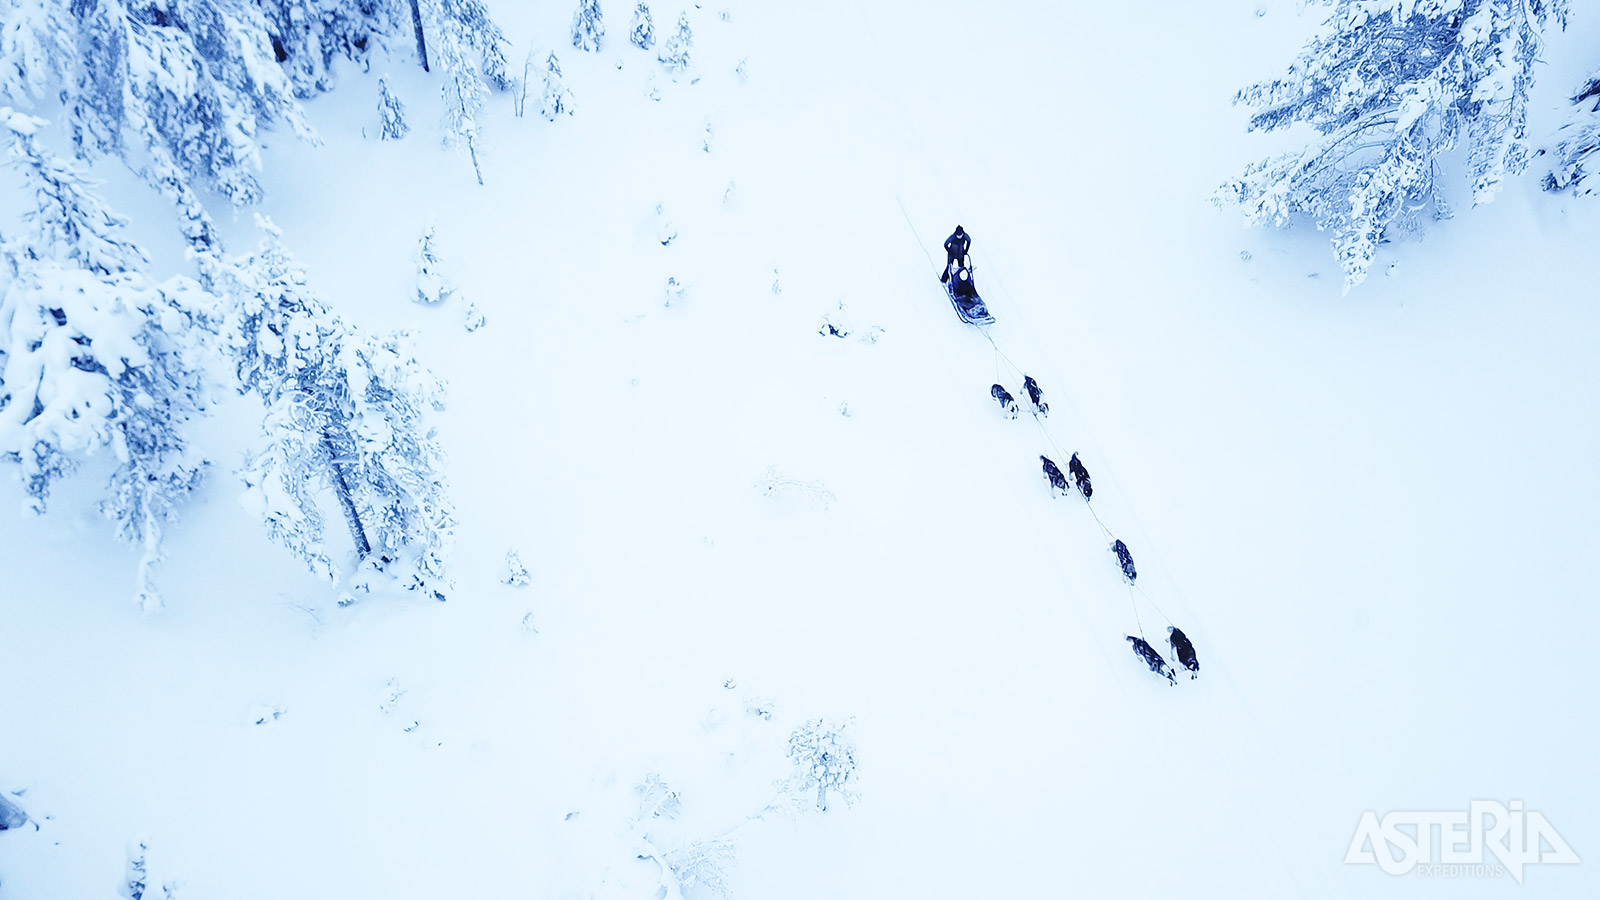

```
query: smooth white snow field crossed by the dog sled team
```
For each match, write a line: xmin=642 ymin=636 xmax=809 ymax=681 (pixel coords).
xmin=0 ymin=0 xmax=1600 ymax=900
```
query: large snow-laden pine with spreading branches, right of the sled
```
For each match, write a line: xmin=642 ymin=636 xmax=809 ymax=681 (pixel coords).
xmin=1218 ymin=0 xmax=1566 ymax=290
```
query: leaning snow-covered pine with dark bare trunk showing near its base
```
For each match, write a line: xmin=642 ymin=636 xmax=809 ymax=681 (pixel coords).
xmin=202 ymin=221 xmax=454 ymax=599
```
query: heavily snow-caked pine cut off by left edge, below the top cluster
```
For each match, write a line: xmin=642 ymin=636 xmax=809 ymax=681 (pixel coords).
xmin=0 ymin=107 xmax=216 ymax=612
